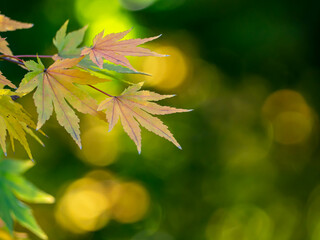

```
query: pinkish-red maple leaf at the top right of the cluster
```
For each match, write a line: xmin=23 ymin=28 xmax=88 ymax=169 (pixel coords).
xmin=81 ymin=29 xmax=167 ymax=71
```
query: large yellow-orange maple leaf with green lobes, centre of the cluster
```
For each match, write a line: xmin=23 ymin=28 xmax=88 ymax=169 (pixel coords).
xmin=17 ymin=57 xmax=109 ymax=148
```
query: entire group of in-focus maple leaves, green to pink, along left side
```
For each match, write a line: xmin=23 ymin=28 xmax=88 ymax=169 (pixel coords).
xmin=0 ymin=14 xmax=189 ymax=238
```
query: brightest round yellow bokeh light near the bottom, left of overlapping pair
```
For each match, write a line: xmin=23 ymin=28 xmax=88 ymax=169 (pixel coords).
xmin=55 ymin=175 xmax=111 ymax=233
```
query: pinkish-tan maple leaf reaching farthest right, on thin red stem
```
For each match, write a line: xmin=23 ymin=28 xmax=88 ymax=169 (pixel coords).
xmin=98 ymin=83 xmax=191 ymax=153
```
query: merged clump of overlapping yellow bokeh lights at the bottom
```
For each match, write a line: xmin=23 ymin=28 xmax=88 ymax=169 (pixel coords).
xmin=55 ymin=170 xmax=150 ymax=234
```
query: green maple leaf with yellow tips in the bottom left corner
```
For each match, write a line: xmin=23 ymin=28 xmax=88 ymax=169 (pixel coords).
xmin=0 ymin=156 xmax=54 ymax=239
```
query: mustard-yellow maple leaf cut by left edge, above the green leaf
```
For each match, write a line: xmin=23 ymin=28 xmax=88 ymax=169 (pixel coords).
xmin=0 ymin=89 xmax=43 ymax=159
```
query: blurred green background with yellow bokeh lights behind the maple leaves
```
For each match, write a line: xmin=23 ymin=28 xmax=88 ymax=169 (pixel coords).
xmin=0 ymin=0 xmax=320 ymax=240
